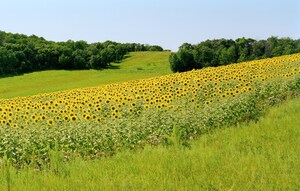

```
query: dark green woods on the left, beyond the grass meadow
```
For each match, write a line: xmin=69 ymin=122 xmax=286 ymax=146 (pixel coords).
xmin=0 ymin=31 xmax=163 ymax=76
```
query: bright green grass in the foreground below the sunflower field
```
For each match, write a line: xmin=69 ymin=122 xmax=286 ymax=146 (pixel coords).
xmin=0 ymin=98 xmax=300 ymax=190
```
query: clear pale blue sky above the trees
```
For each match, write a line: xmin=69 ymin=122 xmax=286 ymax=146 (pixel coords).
xmin=0 ymin=0 xmax=300 ymax=51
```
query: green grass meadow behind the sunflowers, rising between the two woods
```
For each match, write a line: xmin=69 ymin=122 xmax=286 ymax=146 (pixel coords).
xmin=0 ymin=52 xmax=171 ymax=99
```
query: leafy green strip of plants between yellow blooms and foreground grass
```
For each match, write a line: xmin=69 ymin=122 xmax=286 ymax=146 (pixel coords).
xmin=0 ymin=74 xmax=300 ymax=169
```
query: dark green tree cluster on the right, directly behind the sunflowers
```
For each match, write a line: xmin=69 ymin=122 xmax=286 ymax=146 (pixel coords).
xmin=169 ymin=36 xmax=300 ymax=72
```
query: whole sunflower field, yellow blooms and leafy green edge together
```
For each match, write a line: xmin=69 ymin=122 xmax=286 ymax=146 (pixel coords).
xmin=0 ymin=54 xmax=300 ymax=167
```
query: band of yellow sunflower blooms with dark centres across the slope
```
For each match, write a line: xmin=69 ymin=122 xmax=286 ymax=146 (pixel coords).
xmin=0 ymin=54 xmax=300 ymax=128
